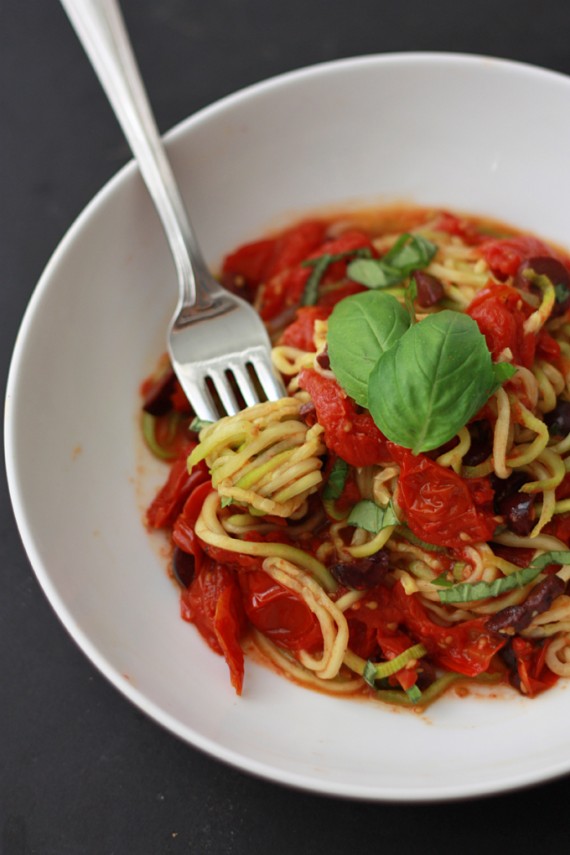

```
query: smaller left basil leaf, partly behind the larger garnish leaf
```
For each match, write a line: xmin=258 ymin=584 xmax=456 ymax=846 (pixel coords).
xmin=327 ymin=291 xmax=410 ymax=407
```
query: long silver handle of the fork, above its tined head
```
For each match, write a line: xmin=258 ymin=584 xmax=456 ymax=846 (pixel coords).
xmin=61 ymin=0 xmax=221 ymax=309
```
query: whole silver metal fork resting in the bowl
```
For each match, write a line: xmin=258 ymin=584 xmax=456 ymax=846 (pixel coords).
xmin=61 ymin=0 xmax=285 ymax=421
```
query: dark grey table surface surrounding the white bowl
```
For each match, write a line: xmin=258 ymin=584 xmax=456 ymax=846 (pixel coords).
xmin=0 ymin=0 xmax=570 ymax=855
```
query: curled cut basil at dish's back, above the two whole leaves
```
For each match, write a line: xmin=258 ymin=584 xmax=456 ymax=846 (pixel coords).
xmin=347 ymin=234 xmax=437 ymax=288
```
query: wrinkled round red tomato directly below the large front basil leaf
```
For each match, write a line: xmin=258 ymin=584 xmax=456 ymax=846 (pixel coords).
xmin=388 ymin=443 xmax=496 ymax=550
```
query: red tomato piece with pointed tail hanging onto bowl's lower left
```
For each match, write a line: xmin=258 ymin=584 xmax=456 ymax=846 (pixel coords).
xmin=181 ymin=559 xmax=245 ymax=695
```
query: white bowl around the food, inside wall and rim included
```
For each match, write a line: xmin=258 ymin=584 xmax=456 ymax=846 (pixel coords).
xmin=6 ymin=54 xmax=570 ymax=800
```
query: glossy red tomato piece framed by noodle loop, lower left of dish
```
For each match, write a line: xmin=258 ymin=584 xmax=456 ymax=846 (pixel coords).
xmin=239 ymin=570 xmax=323 ymax=652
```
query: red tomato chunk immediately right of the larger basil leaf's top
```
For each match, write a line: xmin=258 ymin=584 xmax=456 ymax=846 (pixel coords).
xmin=467 ymin=284 xmax=536 ymax=368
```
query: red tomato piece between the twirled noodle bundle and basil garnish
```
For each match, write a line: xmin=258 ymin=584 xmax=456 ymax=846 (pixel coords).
xmin=299 ymin=368 xmax=390 ymax=466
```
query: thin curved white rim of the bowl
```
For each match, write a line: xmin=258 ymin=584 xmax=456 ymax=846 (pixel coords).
xmin=4 ymin=51 xmax=570 ymax=803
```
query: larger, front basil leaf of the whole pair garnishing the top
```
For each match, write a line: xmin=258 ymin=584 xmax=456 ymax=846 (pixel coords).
xmin=368 ymin=311 xmax=498 ymax=454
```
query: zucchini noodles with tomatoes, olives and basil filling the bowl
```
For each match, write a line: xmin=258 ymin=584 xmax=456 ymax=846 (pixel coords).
xmin=142 ymin=208 xmax=570 ymax=709
